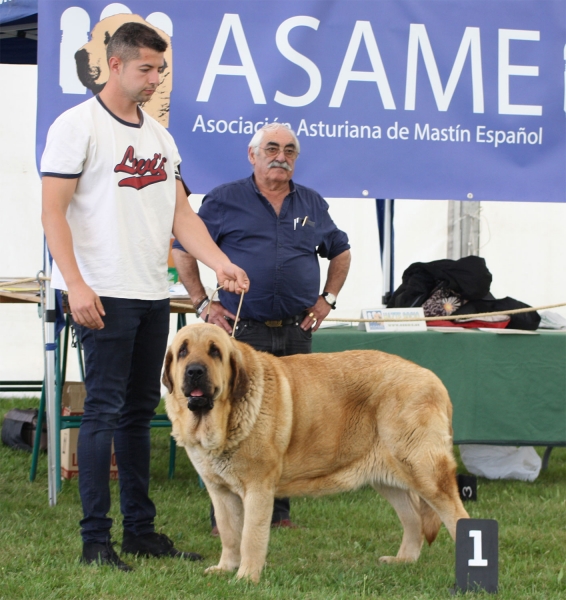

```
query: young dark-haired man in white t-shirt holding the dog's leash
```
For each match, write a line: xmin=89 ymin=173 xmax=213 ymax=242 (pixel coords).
xmin=41 ymin=23 xmax=249 ymax=571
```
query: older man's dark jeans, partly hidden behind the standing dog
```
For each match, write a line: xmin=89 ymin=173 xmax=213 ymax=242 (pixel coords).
xmin=210 ymin=315 xmax=312 ymax=527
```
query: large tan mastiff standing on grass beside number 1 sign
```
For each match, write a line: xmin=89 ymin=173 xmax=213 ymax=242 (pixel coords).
xmin=163 ymin=323 xmax=469 ymax=582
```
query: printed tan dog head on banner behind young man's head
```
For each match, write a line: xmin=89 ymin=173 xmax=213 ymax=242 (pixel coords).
xmin=75 ymin=14 xmax=173 ymax=127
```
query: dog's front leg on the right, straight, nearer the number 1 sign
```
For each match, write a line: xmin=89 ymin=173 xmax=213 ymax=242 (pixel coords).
xmin=238 ymin=487 xmax=274 ymax=583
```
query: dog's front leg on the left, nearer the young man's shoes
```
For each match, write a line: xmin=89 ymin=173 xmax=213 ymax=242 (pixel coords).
xmin=205 ymin=485 xmax=244 ymax=573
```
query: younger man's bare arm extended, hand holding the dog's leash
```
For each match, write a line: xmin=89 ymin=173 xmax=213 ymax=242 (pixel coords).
xmin=173 ymin=180 xmax=250 ymax=297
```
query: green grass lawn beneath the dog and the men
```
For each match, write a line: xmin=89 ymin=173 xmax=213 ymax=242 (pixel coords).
xmin=0 ymin=399 xmax=566 ymax=600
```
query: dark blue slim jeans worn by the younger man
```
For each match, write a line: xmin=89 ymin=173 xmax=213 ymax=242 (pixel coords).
xmin=75 ymin=297 xmax=169 ymax=543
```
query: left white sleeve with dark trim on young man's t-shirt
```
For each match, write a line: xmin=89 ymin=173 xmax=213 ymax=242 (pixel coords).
xmin=40 ymin=117 xmax=90 ymax=179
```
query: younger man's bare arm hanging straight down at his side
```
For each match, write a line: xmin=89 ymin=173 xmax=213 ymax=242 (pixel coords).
xmin=41 ymin=176 xmax=106 ymax=329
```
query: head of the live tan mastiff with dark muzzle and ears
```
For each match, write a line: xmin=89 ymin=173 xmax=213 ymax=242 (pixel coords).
xmin=162 ymin=323 xmax=253 ymax=431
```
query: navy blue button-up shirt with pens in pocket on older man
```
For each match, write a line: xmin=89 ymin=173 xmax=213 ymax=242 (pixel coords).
xmin=174 ymin=176 xmax=350 ymax=321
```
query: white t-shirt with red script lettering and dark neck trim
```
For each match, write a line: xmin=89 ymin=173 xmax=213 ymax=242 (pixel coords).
xmin=41 ymin=96 xmax=181 ymax=300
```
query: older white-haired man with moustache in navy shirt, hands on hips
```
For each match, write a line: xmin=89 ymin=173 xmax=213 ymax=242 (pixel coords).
xmin=173 ymin=123 xmax=350 ymax=527
